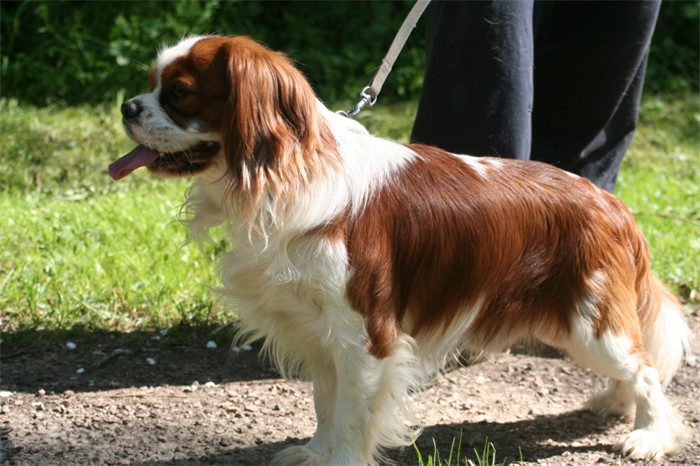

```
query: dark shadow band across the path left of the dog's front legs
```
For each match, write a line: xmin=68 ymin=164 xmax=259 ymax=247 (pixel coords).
xmin=0 ymin=327 xmax=279 ymax=393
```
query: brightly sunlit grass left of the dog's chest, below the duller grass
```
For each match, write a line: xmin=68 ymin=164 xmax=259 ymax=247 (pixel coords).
xmin=0 ymin=182 xmax=223 ymax=331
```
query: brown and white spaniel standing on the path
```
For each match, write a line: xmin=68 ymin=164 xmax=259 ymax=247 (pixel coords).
xmin=110 ymin=36 xmax=690 ymax=464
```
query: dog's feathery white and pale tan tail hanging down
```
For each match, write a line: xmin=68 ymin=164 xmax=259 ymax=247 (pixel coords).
xmin=637 ymin=271 xmax=691 ymax=387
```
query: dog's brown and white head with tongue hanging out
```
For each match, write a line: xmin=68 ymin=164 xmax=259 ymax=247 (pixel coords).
xmin=109 ymin=36 xmax=335 ymax=202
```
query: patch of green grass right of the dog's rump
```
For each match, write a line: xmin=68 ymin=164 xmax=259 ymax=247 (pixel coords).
xmin=616 ymin=94 xmax=700 ymax=296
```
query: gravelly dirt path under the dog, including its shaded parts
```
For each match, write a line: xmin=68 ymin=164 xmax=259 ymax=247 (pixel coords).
xmin=0 ymin=316 xmax=700 ymax=466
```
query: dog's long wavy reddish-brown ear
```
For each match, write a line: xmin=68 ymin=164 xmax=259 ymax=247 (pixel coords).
xmin=221 ymin=37 xmax=320 ymax=204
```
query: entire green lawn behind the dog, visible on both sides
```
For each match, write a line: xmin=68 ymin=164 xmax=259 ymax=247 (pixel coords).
xmin=0 ymin=95 xmax=700 ymax=346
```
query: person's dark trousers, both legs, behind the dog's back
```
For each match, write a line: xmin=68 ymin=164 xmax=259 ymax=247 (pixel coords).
xmin=411 ymin=0 xmax=661 ymax=191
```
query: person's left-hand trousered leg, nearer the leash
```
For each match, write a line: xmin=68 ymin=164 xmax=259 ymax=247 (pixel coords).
xmin=411 ymin=1 xmax=533 ymax=159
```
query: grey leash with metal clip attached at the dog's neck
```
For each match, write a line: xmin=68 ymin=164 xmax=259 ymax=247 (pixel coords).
xmin=338 ymin=0 xmax=430 ymax=118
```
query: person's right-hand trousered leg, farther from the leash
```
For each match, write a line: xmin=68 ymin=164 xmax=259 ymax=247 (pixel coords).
xmin=531 ymin=0 xmax=660 ymax=191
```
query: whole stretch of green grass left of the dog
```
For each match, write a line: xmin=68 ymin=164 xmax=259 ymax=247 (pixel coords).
xmin=0 ymin=97 xmax=227 ymax=345
